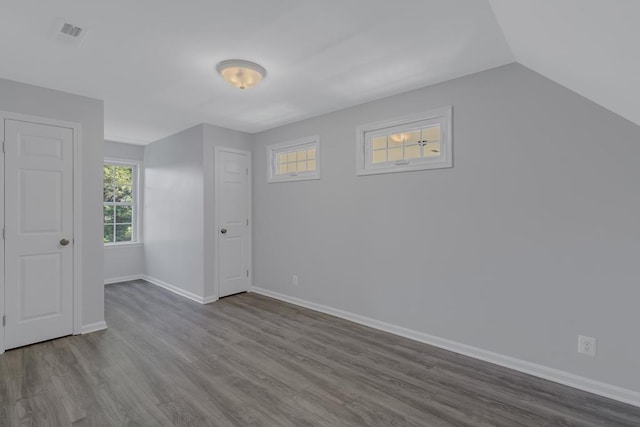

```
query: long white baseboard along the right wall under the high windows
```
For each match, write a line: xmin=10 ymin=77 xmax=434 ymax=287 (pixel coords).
xmin=251 ymin=287 xmax=640 ymax=407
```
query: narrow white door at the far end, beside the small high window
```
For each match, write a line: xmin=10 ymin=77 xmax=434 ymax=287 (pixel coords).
xmin=216 ymin=147 xmax=251 ymax=298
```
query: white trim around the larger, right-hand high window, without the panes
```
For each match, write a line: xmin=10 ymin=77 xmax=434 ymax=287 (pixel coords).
xmin=356 ymin=106 xmax=453 ymax=176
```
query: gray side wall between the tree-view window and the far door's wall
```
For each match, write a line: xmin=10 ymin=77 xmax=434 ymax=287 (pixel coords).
xmin=143 ymin=125 xmax=204 ymax=297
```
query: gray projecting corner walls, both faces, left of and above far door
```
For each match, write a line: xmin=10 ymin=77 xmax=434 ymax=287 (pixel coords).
xmin=143 ymin=124 xmax=251 ymax=298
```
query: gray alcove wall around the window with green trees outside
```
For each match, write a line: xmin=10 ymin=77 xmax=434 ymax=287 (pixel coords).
xmin=104 ymin=141 xmax=144 ymax=283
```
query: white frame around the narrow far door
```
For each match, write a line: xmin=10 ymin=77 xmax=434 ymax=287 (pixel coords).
xmin=213 ymin=145 xmax=253 ymax=299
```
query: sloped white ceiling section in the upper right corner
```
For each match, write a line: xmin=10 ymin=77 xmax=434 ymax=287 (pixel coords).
xmin=491 ymin=0 xmax=640 ymax=124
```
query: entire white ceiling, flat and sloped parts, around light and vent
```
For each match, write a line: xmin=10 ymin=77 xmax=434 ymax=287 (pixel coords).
xmin=0 ymin=0 xmax=640 ymax=143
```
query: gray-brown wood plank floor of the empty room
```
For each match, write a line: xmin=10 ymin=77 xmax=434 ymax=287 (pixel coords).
xmin=0 ymin=281 xmax=640 ymax=426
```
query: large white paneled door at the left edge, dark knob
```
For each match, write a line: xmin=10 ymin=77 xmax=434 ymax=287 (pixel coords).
xmin=4 ymin=119 xmax=74 ymax=349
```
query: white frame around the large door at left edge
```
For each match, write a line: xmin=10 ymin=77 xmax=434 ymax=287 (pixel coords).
xmin=0 ymin=111 xmax=82 ymax=354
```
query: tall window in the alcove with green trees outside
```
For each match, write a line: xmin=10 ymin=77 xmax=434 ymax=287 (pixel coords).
xmin=102 ymin=160 xmax=138 ymax=245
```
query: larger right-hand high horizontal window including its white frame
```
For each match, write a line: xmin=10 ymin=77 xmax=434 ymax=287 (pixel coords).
xmin=356 ymin=107 xmax=453 ymax=175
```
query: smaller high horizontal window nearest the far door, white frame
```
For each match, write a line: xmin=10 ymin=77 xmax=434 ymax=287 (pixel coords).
xmin=267 ymin=136 xmax=320 ymax=182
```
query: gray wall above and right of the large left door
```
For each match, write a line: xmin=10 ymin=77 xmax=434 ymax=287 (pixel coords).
xmin=0 ymin=79 xmax=104 ymax=325
